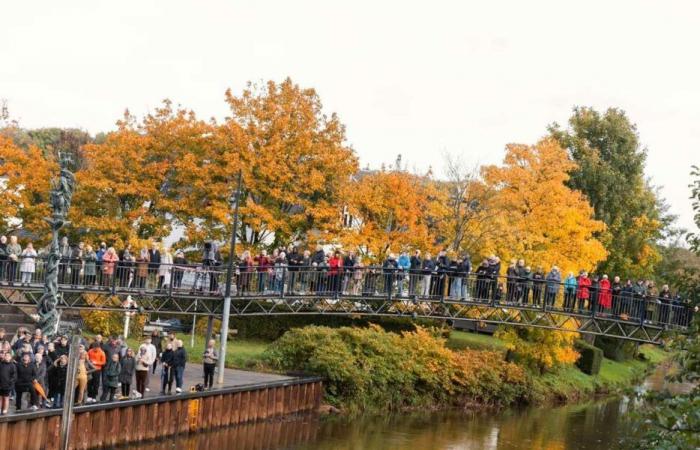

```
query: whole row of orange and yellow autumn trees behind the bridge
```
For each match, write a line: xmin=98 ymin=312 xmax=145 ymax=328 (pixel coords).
xmin=0 ymin=79 xmax=608 ymax=278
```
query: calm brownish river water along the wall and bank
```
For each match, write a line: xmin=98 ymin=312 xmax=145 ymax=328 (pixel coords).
xmin=138 ymin=368 xmax=684 ymax=450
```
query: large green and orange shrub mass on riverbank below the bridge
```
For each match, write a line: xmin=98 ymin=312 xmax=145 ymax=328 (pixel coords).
xmin=264 ymin=325 xmax=526 ymax=411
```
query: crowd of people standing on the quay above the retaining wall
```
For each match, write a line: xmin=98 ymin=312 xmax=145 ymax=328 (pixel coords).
xmin=0 ymin=327 xmax=218 ymax=414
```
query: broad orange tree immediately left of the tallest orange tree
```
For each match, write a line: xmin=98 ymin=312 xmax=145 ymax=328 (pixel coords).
xmin=71 ymin=101 xmax=217 ymax=243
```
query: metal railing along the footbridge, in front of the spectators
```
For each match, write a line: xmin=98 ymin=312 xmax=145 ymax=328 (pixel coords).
xmin=0 ymin=257 xmax=694 ymax=328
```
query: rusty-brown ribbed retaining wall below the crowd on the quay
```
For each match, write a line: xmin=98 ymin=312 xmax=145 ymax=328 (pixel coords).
xmin=0 ymin=378 xmax=323 ymax=450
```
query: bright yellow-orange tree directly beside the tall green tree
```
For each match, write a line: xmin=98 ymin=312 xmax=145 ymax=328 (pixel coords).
xmin=484 ymin=138 xmax=606 ymax=271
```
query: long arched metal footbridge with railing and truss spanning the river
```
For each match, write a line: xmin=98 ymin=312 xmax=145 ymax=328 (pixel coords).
xmin=0 ymin=261 xmax=694 ymax=344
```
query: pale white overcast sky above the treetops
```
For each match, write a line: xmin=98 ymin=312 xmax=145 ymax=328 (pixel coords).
xmin=0 ymin=0 xmax=700 ymax=232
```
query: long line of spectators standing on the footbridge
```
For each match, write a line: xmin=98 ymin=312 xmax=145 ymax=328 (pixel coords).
xmin=0 ymin=236 xmax=689 ymax=325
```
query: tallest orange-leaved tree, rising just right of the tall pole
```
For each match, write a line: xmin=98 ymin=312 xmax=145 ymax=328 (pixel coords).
xmin=217 ymin=78 xmax=357 ymax=245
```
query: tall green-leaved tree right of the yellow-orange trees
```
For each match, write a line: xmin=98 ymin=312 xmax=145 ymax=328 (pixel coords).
xmin=549 ymin=107 xmax=673 ymax=277
